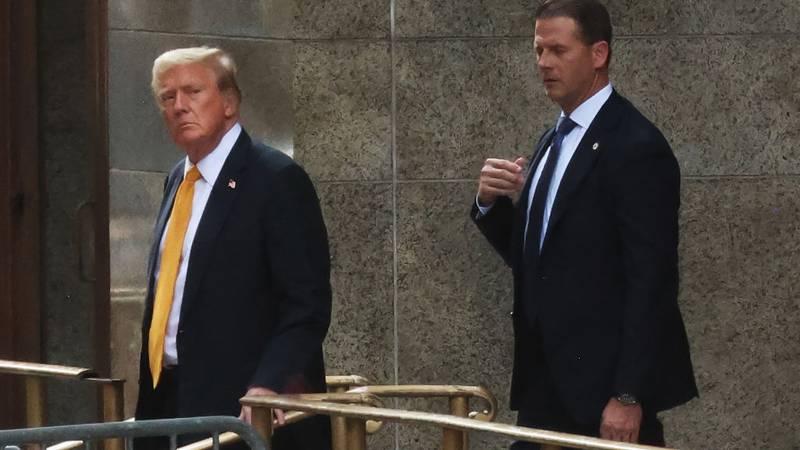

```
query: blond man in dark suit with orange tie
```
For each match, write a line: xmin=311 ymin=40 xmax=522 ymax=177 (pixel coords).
xmin=136 ymin=47 xmax=331 ymax=450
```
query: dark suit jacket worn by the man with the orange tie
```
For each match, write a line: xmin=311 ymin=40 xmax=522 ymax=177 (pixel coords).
xmin=137 ymin=131 xmax=331 ymax=448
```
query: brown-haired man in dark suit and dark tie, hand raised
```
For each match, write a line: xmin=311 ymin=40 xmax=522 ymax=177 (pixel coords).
xmin=472 ymin=0 xmax=697 ymax=449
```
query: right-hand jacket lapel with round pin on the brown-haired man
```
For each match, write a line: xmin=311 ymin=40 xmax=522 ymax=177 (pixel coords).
xmin=542 ymin=91 xmax=622 ymax=252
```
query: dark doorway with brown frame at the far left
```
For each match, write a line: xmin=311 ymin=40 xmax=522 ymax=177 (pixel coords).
xmin=0 ymin=0 xmax=110 ymax=428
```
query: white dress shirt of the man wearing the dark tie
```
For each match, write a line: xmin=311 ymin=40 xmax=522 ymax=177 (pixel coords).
xmin=476 ymin=84 xmax=613 ymax=250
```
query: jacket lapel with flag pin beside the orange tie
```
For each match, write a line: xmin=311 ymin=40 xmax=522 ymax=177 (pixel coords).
xmin=180 ymin=130 xmax=252 ymax=320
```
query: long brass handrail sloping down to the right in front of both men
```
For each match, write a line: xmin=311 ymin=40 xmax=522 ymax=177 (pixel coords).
xmin=240 ymin=395 xmax=676 ymax=450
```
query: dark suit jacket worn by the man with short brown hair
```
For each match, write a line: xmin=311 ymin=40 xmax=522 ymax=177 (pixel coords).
xmin=472 ymin=92 xmax=697 ymax=423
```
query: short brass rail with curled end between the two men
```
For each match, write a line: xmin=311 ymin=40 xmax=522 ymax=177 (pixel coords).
xmin=347 ymin=384 xmax=498 ymax=422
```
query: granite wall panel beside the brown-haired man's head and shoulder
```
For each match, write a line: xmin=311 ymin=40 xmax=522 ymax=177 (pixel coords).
xmin=611 ymin=36 xmax=800 ymax=176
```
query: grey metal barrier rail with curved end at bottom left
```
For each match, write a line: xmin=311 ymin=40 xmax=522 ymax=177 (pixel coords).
xmin=0 ymin=416 xmax=267 ymax=450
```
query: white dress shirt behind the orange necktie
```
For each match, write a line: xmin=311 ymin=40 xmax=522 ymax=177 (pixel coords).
xmin=155 ymin=123 xmax=242 ymax=366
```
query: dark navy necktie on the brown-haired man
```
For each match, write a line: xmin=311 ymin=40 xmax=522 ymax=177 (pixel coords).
xmin=525 ymin=117 xmax=577 ymax=257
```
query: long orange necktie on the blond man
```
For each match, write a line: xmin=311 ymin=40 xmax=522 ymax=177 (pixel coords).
xmin=147 ymin=166 xmax=201 ymax=389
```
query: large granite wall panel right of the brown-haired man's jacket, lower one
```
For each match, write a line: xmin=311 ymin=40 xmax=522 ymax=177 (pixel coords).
xmin=664 ymin=177 xmax=800 ymax=449
